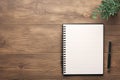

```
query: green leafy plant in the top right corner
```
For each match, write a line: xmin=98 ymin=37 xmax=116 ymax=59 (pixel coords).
xmin=92 ymin=0 xmax=120 ymax=20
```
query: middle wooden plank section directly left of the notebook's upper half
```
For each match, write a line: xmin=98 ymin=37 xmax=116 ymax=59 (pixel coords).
xmin=0 ymin=24 xmax=62 ymax=54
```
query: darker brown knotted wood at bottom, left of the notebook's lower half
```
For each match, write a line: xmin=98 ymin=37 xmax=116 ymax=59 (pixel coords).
xmin=0 ymin=53 xmax=62 ymax=80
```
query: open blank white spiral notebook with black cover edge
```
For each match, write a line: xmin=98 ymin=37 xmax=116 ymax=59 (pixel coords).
xmin=62 ymin=24 xmax=104 ymax=75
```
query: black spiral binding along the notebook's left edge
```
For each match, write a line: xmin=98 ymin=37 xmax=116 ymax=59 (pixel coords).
xmin=63 ymin=26 xmax=66 ymax=74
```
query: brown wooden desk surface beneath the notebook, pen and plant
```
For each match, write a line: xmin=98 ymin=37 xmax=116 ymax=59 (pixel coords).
xmin=0 ymin=0 xmax=120 ymax=80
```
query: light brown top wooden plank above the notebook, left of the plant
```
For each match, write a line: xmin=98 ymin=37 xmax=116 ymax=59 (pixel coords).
xmin=0 ymin=0 xmax=105 ymax=24
